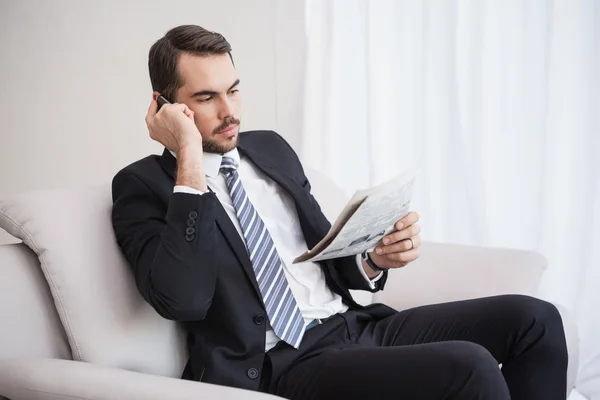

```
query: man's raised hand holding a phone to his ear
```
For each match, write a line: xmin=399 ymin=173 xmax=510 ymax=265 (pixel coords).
xmin=146 ymin=93 xmax=202 ymax=153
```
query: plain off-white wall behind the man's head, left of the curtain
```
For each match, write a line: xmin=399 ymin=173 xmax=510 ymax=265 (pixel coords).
xmin=0 ymin=0 xmax=304 ymax=242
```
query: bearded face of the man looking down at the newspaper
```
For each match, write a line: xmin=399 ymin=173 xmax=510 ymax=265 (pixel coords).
xmin=175 ymin=53 xmax=241 ymax=154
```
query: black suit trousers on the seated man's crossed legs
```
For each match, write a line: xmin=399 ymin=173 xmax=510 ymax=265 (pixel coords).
xmin=261 ymin=295 xmax=568 ymax=400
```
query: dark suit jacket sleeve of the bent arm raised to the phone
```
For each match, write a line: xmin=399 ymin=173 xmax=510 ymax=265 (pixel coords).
xmin=112 ymin=170 xmax=218 ymax=321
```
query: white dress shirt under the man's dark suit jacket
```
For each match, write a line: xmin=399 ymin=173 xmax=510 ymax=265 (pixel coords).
xmin=172 ymin=149 xmax=382 ymax=351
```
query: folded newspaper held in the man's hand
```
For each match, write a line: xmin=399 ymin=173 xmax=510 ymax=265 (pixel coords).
xmin=293 ymin=168 xmax=416 ymax=264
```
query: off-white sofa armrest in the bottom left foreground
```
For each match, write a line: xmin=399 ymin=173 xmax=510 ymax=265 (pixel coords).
xmin=0 ymin=359 xmax=278 ymax=400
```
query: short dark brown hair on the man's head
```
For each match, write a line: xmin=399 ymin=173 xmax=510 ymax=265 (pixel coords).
xmin=148 ymin=25 xmax=233 ymax=102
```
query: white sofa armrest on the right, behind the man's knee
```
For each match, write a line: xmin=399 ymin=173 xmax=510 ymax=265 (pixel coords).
xmin=374 ymin=242 xmax=547 ymax=310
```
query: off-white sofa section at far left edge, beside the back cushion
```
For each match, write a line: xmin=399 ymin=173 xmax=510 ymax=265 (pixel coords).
xmin=0 ymin=244 xmax=71 ymax=359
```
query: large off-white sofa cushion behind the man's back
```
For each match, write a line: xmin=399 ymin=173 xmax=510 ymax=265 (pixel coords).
xmin=0 ymin=184 xmax=187 ymax=377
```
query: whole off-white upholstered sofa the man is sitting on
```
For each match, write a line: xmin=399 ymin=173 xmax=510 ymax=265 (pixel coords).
xmin=0 ymin=167 xmax=578 ymax=400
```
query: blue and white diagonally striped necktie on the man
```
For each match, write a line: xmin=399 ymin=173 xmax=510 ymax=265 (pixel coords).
xmin=220 ymin=157 xmax=306 ymax=348
